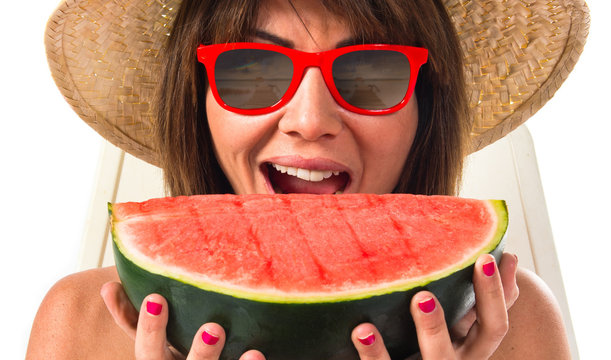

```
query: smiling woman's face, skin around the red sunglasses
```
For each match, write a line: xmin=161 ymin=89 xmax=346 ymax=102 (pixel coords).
xmin=206 ymin=0 xmax=418 ymax=194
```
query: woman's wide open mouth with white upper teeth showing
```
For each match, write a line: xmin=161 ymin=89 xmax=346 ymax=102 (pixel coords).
xmin=263 ymin=163 xmax=350 ymax=194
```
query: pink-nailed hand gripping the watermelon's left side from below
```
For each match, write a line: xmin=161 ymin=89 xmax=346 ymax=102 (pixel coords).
xmin=101 ymin=282 xmax=265 ymax=360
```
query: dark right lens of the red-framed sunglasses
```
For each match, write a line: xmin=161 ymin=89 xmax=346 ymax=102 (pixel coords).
xmin=332 ymin=50 xmax=410 ymax=110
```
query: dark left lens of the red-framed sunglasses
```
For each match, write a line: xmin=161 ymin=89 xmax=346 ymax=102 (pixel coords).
xmin=214 ymin=49 xmax=293 ymax=109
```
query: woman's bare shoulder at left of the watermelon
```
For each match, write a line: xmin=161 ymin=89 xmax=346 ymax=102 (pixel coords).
xmin=26 ymin=267 xmax=133 ymax=359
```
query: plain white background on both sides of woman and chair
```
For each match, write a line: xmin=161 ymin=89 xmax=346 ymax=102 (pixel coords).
xmin=0 ymin=0 xmax=611 ymax=359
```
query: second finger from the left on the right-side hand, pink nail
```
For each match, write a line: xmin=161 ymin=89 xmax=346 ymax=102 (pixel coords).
xmin=410 ymin=291 xmax=455 ymax=359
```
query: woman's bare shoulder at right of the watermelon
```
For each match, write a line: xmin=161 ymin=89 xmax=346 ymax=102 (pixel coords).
xmin=494 ymin=269 xmax=570 ymax=360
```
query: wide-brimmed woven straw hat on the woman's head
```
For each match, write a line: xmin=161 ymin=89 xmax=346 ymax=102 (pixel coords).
xmin=45 ymin=0 xmax=590 ymax=164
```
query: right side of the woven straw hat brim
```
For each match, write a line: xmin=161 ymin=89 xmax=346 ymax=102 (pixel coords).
xmin=444 ymin=0 xmax=590 ymax=151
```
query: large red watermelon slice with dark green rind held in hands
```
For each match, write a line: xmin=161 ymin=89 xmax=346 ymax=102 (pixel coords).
xmin=109 ymin=194 xmax=508 ymax=359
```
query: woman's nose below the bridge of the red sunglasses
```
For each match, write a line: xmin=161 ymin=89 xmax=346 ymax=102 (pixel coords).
xmin=278 ymin=67 xmax=343 ymax=141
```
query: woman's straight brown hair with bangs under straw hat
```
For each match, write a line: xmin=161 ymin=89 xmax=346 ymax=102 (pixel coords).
xmin=156 ymin=0 xmax=470 ymax=195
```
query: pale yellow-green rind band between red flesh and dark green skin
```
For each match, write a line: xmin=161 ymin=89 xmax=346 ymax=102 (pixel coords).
xmin=108 ymin=200 xmax=508 ymax=304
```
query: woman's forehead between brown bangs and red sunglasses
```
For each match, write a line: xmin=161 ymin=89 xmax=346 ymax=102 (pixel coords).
xmin=256 ymin=0 xmax=352 ymax=50
